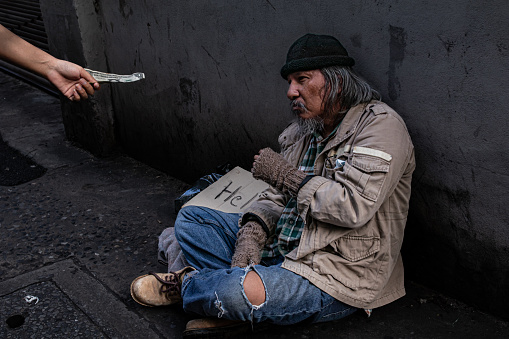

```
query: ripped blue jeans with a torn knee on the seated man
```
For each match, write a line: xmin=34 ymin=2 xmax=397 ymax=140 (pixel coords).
xmin=175 ymin=206 xmax=357 ymax=325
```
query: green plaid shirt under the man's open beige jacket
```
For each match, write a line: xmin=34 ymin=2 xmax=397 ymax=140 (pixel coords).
xmin=262 ymin=125 xmax=339 ymax=258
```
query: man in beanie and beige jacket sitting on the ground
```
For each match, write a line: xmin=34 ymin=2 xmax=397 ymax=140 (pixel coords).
xmin=131 ymin=34 xmax=415 ymax=334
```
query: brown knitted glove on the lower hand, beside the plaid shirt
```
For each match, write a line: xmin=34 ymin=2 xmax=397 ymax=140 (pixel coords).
xmin=231 ymin=221 xmax=267 ymax=267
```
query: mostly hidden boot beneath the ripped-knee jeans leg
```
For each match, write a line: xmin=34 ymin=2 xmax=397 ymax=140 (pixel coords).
xmin=184 ymin=318 xmax=252 ymax=338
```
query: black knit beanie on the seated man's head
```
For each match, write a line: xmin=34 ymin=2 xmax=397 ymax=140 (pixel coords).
xmin=281 ymin=34 xmax=355 ymax=79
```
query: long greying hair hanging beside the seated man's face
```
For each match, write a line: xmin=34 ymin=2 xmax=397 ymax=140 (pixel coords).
xmin=320 ymin=66 xmax=381 ymax=116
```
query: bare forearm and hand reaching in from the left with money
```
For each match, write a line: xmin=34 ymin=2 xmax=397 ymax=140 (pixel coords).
xmin=0 ymin=25 xmax=100 ymax=101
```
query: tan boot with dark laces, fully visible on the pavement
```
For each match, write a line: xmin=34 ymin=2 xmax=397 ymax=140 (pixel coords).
xmin=131 ymin=266 xmax=195 ymax=306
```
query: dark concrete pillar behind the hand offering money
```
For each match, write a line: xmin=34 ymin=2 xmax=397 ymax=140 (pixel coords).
xmin=40 ymin=0 xmax=117 ymax=156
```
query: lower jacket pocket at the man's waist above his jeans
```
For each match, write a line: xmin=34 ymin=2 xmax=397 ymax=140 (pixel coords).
xmin=330 ymin=235 xmax=380 ymax=262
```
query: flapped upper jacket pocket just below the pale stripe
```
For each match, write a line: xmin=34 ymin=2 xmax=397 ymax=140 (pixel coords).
xmin=346 ymin=154 xmax=390 ymax=201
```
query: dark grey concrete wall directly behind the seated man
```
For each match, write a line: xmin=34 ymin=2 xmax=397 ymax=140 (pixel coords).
xmin=42 ymin=0 xmax=509 ymax=317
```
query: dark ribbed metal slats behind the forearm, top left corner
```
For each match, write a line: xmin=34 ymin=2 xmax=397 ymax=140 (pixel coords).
xmin=0 ymin=0 xmax=58 ymax=96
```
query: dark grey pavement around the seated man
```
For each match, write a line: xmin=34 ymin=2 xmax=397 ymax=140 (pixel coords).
xmin=0 ymin=73 xmax=509 ymax=338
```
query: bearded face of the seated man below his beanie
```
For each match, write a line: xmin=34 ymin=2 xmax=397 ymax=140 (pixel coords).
xmin=286 ymin=69 xmax=325 ymax=120
